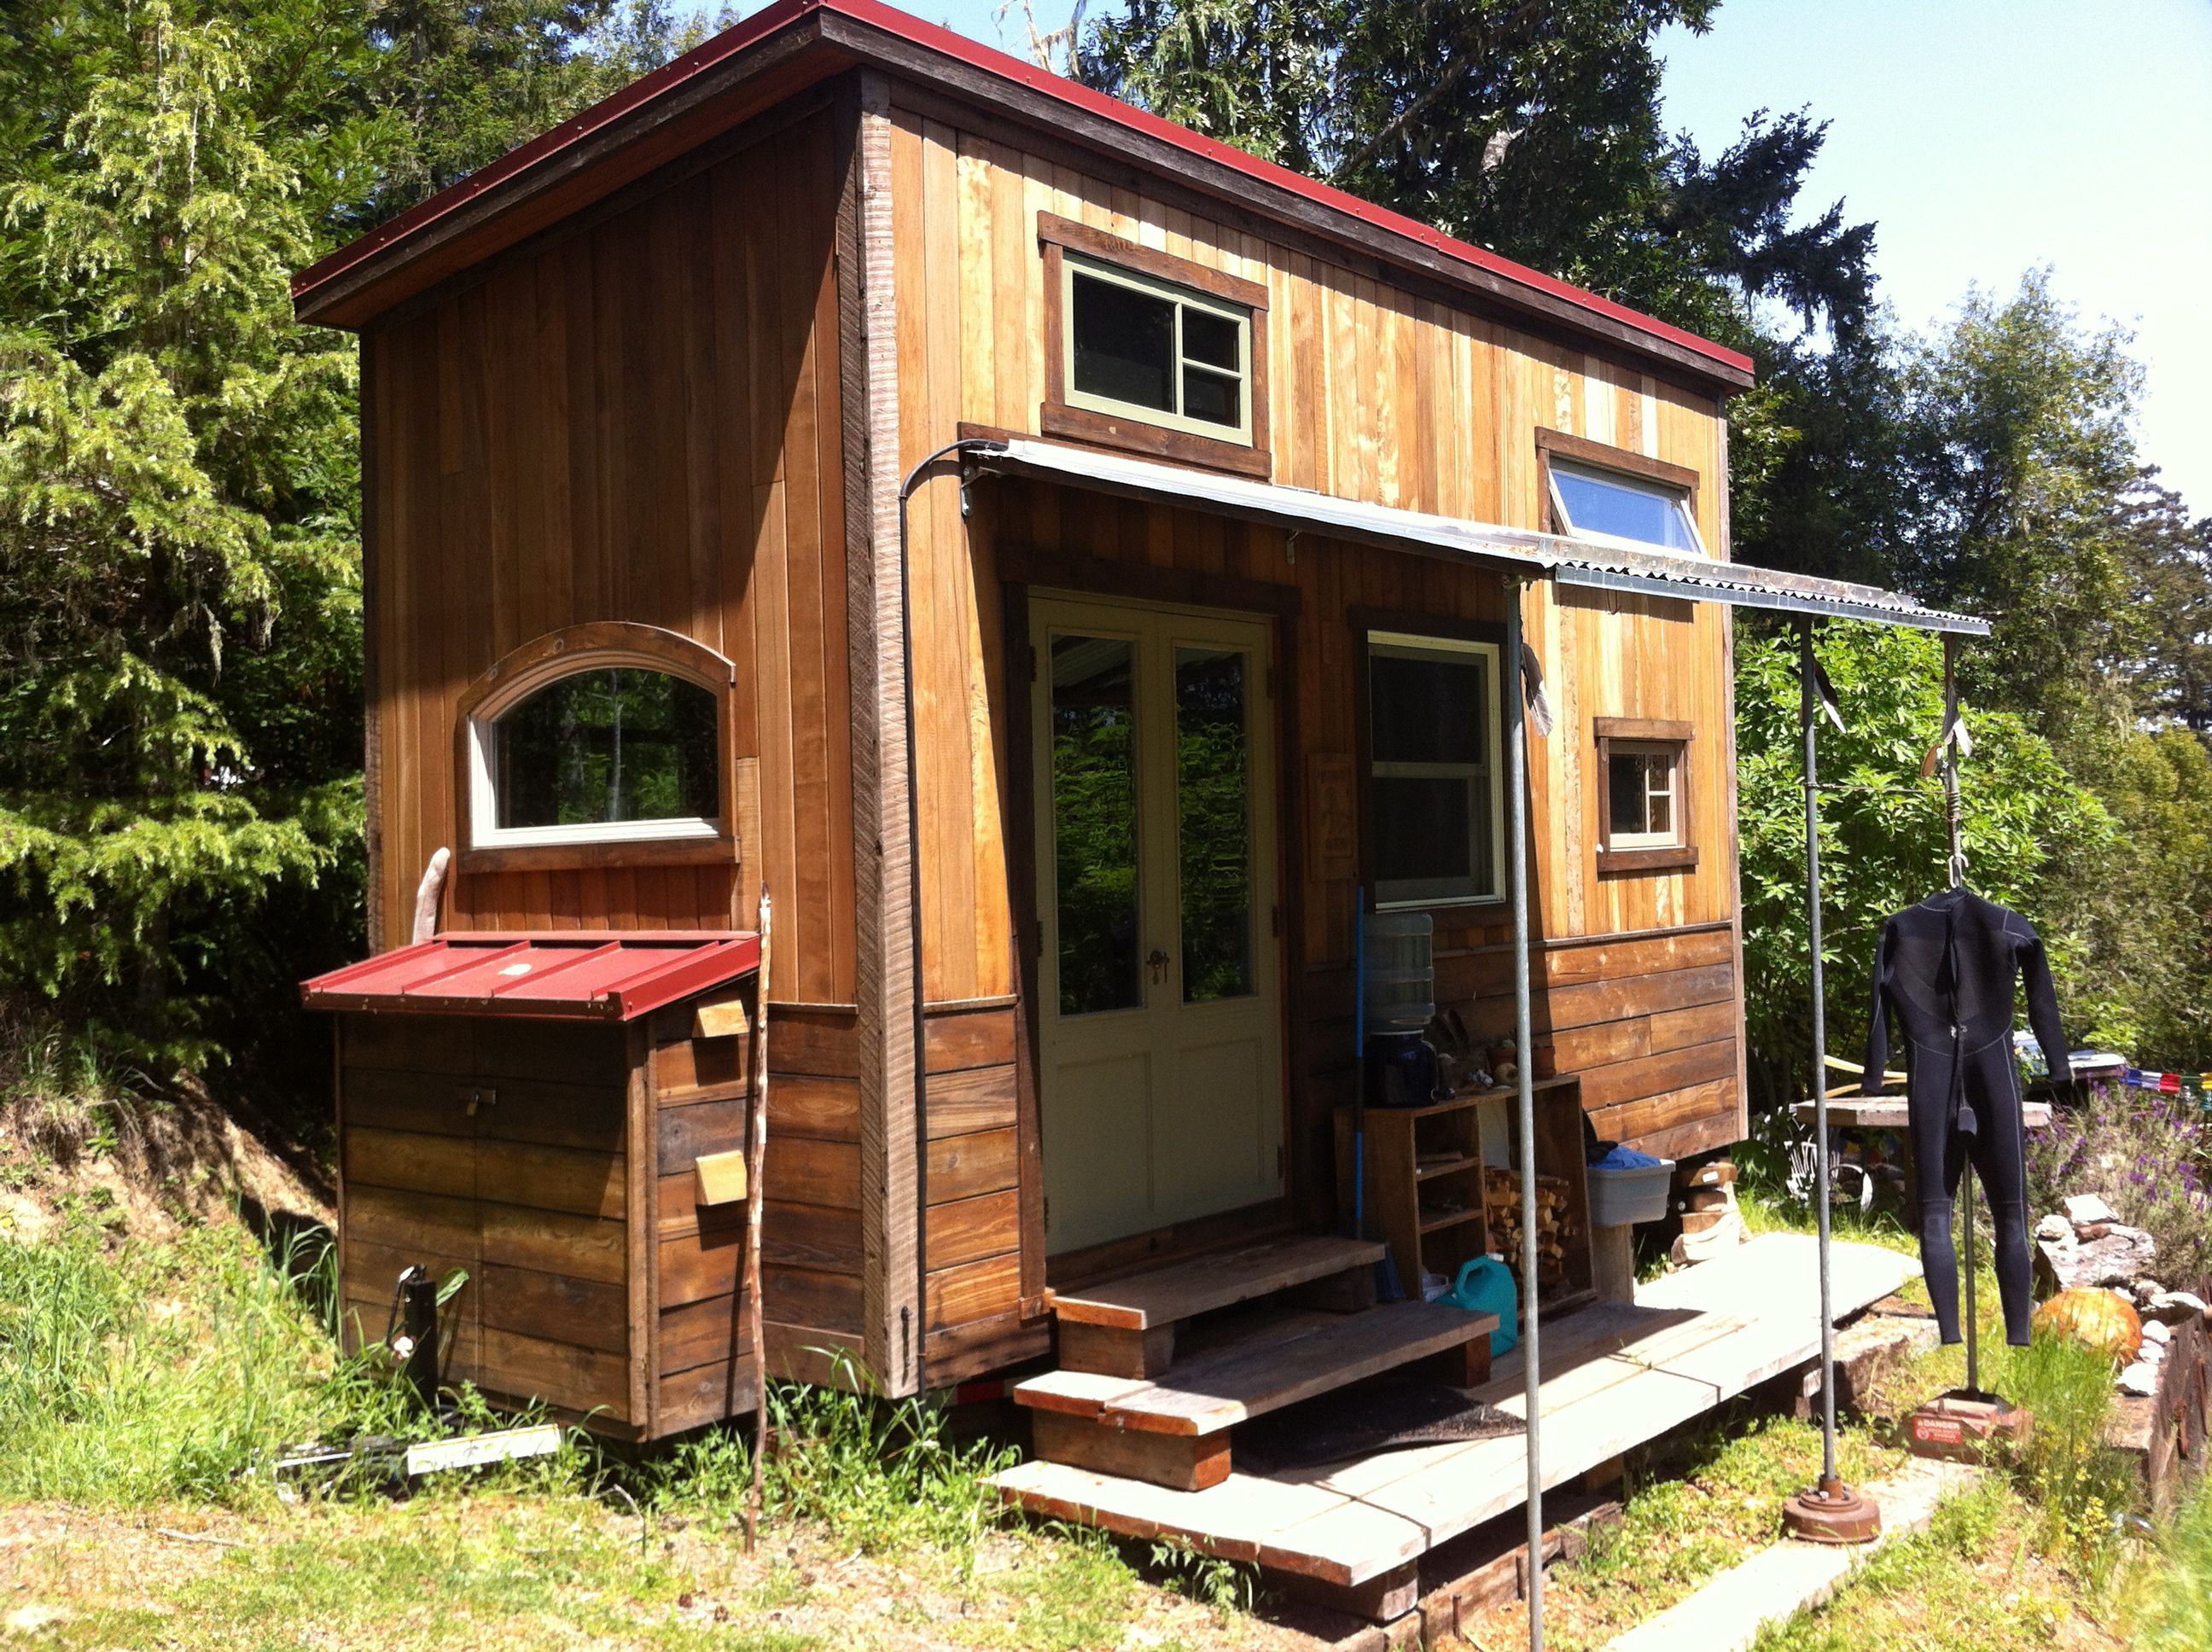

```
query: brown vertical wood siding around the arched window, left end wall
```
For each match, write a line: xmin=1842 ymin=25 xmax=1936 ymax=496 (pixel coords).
xmin=363 ymin=113 xmax=854 ymax=1004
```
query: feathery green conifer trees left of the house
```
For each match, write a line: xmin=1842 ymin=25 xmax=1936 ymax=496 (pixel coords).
xmin=0 ymin=0 xmax=684 ymax=1077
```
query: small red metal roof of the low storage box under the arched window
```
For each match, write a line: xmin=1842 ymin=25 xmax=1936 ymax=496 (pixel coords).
xmin=299 ymin=929 xmax=761 ymax=1021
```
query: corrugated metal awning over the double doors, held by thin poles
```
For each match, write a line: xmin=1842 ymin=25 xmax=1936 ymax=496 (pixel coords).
xmin=963 ymin=436 xmax=1988 ymax=637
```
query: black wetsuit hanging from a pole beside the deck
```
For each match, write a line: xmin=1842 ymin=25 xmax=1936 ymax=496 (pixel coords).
xmin=1862 ymin=889 xmax=2070 ymax=1345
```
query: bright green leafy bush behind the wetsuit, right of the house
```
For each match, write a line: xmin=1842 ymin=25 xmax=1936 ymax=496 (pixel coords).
xmin=1737 ymin=621 xmax=2112 ymax=1099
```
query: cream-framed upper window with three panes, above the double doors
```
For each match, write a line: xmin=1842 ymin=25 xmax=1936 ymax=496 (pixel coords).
xmin=1062 ymin=252 xmax=1252 ymax=442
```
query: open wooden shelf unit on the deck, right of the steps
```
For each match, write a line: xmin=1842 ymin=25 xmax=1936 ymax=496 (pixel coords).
xmin=1336 ymin=1077 xmax=1591 ymax=1309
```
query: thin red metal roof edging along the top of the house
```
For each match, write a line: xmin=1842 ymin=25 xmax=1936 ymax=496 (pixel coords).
xmin=292 ymin=0 xmax=1752 ymax=378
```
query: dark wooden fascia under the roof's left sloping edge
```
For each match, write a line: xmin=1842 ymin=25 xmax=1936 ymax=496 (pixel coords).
xmin=292 ymin=0 xmax=854 ymax=328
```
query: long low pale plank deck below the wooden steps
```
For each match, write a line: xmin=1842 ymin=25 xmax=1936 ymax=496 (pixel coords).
xmin=998 ymin=1234 xmax=1918 ymax=1588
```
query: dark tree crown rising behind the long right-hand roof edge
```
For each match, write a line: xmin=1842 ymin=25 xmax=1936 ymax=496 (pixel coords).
xmin=1080 ymin=0 xmax=1873 ymax=343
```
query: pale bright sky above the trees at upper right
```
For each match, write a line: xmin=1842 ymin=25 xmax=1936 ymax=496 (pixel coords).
xmin=853 ymin=0 xmax=2212 ymax=513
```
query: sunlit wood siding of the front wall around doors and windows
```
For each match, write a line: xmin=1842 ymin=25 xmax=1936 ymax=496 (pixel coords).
xmin=892 ymin=93 xmax=1741 ymax=1283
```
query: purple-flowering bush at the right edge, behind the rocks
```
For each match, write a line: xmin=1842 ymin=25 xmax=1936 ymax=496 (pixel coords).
xmin=2029 ymin=1086 xmax=2212 ymax=1289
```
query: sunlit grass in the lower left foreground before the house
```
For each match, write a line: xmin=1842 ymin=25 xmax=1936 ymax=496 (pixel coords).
xmin=0 ymin=1210 xmax=1249 ymax=1652
